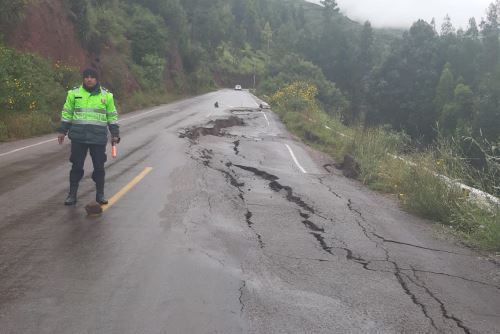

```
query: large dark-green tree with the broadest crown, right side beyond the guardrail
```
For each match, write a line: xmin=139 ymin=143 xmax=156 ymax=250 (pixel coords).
xmin=367 ymin=20 xmax=440 ymax=141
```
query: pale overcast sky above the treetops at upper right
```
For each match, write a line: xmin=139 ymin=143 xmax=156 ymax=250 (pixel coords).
xmin=307 ymin=0 xmax=494 ymax=31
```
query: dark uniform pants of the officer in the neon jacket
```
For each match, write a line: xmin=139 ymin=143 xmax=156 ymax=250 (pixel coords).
xmin=69 ymin=141 xmax=107 ymax=193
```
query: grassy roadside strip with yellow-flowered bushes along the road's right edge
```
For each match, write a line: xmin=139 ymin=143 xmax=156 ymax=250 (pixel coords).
xmin=269 ymin=82 xmax=500 ymax=250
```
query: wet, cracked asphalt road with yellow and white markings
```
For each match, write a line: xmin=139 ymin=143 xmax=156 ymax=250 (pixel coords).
xmin=0 ymin=90 xmax=500 ymax=334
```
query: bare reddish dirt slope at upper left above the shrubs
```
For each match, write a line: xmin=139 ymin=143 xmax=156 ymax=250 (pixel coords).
xmin=6 ymin=0 xmax=91 ymax=68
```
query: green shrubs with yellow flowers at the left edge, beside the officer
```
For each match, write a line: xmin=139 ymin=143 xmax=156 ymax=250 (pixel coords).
xmin=0 ymin=44 xmax=78 ymax=138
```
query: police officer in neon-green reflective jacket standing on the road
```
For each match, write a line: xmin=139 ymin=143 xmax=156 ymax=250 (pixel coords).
xmin=57 ymin=68 xmax=120 ymax=205
